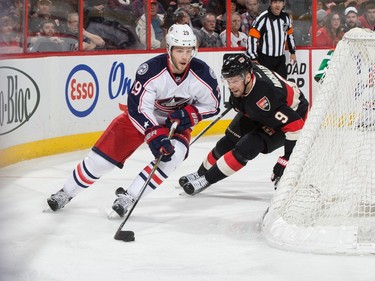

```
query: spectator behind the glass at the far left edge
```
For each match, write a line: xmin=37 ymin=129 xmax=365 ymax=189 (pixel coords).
xmin=0 ymin=16 xmax=22 ymax=54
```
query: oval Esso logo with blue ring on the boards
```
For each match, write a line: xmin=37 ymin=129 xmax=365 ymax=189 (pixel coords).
xmin=65 ymin=64 xmax=99 ymax=117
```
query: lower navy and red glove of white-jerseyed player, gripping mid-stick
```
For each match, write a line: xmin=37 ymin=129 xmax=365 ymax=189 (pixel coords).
xmin=145 ymin=126 xmax=174 ymax=162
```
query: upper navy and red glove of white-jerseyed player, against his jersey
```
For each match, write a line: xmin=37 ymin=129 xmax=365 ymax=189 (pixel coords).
xmin=166 ymin=104 xmax=202 ymax=132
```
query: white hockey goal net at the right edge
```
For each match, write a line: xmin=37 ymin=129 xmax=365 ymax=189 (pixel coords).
xmin=262 ymin=28 xmax=375 ymax=254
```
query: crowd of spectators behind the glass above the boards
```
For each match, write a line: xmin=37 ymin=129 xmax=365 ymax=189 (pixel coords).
xmin=0 ymin=0 xmax=375 ymax=53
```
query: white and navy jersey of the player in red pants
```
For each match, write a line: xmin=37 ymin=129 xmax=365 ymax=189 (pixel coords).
xmin=128 ymin=54 xmax=220 ymax=133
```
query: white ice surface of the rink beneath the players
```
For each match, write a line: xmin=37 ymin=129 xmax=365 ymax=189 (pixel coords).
xmin=0 ymin=137 xmax=375 ymax=281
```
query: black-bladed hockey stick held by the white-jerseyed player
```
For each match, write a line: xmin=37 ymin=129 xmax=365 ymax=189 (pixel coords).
xmin=114 ymin=122 xmax=178 ymax=242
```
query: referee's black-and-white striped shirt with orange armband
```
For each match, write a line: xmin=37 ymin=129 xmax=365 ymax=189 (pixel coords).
xmin=247 ymin=9 xmax=296 ymax=60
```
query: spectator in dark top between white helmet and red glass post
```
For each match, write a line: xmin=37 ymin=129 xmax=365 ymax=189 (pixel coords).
xmin=195 ymin=13 xmax=223 ymax=48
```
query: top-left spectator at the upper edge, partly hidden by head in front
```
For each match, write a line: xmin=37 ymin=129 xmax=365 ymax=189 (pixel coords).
xmin=29 ymin=0 xmax=66 ymax=36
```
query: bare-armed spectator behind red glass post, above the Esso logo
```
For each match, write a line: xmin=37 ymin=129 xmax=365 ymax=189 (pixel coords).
xmin=64 ymin=12 xmax=105 ymax=50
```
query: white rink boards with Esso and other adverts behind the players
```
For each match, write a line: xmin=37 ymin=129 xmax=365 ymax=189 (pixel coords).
xmin=0 ymin=50 xmax=327 ymax=153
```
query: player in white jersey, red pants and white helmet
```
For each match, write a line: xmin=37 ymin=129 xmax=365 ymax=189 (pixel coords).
xmin=47 ymin=25 xmax=220 ymax=216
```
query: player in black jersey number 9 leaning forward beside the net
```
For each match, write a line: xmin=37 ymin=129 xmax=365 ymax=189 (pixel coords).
xmin=179 ymin=54 xmax=309 ymax=195
